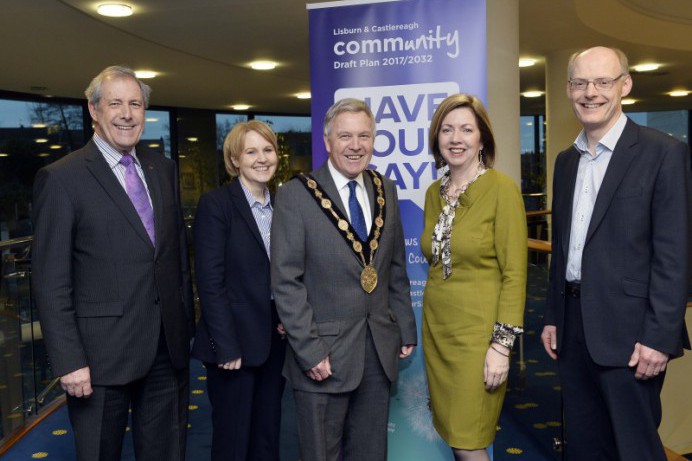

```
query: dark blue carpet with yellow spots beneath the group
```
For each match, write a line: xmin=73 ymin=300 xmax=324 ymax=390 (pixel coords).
xmin=3 ymin=265 xmax=561 ymax=461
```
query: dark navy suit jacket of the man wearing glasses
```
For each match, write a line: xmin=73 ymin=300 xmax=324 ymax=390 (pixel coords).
xmin=545 ymin=120 xmax=692 ymax=366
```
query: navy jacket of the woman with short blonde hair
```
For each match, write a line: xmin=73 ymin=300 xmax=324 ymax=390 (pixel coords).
xmin=192 ymin=179 xmax=276 ymax=366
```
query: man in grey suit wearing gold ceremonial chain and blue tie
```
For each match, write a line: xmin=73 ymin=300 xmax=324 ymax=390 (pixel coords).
xmin=271 ymin=99 xmax=417 ymax=461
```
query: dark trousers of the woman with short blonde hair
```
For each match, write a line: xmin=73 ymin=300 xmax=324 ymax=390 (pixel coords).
xmin=204 ymin=322 xmax=286 ymax=461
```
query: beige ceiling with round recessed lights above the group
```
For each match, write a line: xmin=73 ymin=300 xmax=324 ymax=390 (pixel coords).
xmin=0 ymin=0 xmax=692 ymax=114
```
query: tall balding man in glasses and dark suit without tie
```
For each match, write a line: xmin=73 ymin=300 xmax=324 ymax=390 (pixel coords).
xmin=541 ymin=47 xmax=690 ymax=461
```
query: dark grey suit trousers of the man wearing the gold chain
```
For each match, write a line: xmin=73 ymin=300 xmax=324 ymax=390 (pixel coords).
xmin=294 ymin=329 xmax=391 ymax=461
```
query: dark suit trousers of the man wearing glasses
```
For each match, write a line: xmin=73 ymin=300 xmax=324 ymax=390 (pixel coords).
xmin=558 ymin=296 xmax=666 ymax=461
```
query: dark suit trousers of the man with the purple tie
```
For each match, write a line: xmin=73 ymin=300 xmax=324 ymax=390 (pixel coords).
xmin=67 ymin=328 xmax=189 ymax=461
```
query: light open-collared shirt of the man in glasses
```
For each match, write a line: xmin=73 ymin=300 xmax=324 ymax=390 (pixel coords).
xmin=565 ymin=114 xmax=627 ymax=282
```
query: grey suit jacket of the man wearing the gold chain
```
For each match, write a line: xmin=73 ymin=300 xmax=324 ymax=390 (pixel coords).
xmin=271 ymin=163 xmax=416 ymax=393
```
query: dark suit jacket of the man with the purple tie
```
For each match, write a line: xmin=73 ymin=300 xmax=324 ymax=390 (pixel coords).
xmin=32 ymin=140 xmax=194 ymax=385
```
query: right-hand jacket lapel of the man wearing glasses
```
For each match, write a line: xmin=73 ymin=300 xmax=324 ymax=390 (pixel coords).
xmin=584 ymin=119 xmax=639 ymax=245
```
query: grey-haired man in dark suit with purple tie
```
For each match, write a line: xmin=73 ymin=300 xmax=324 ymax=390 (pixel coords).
xmin=33 ymin=66 xmax=194 ymax=461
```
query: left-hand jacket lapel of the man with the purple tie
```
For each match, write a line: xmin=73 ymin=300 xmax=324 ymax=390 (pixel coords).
xmin=84 ymin=140 xmax=154 ymax=246
